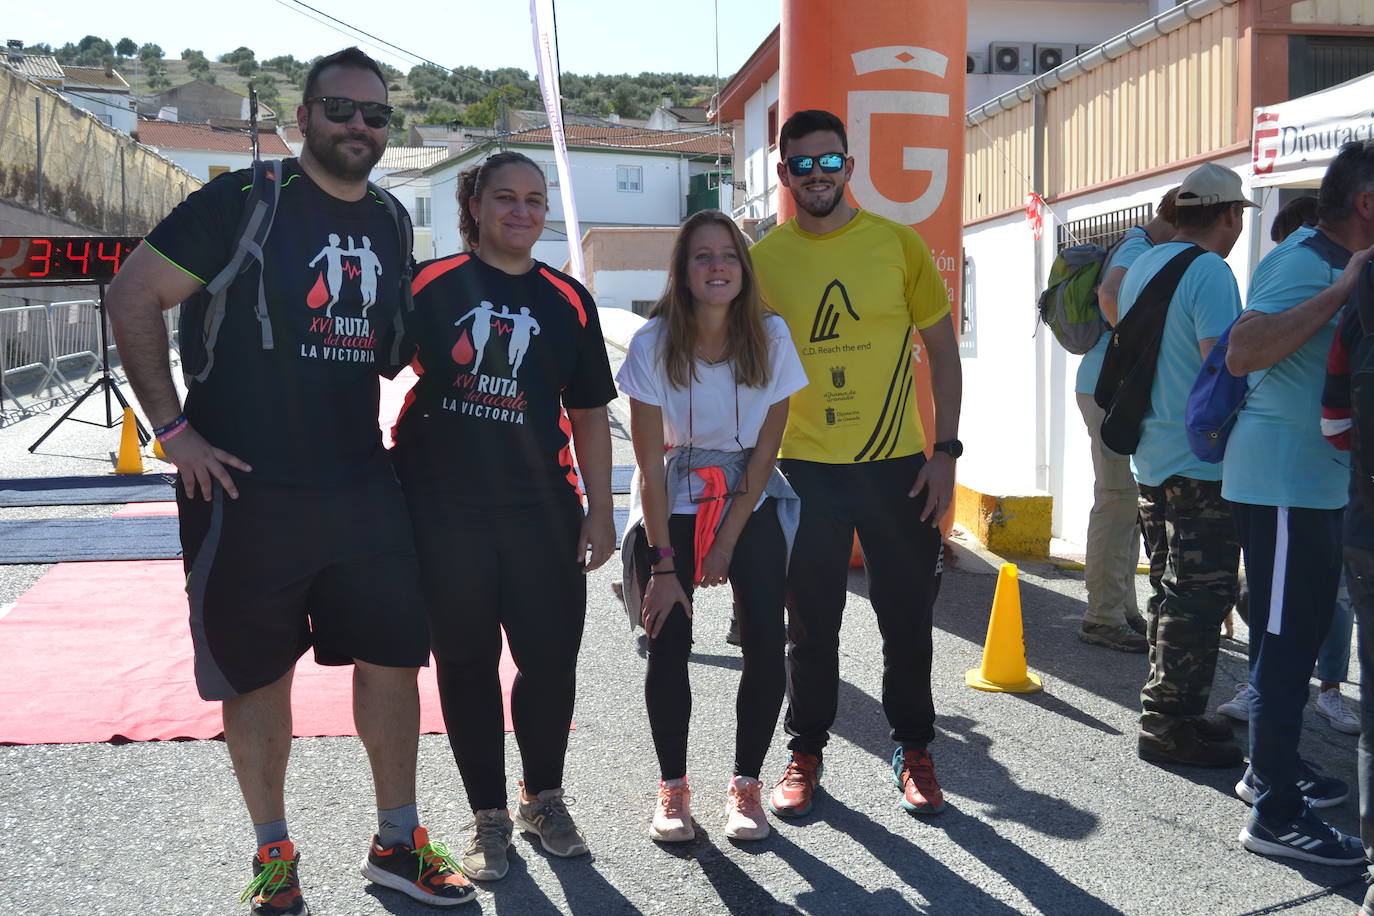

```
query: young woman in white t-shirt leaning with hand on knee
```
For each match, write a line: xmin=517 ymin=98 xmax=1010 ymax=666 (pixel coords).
xmin=617 ymin=210 xmax=807 ymax=842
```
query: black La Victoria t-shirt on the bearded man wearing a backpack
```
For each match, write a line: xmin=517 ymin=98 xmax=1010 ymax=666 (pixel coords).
xmin=147 ymin=159 xmax=409 ymax=486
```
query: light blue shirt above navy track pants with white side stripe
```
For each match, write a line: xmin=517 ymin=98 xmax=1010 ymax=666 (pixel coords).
xmin=1221 ymin=227 xmax=1351 ymax=509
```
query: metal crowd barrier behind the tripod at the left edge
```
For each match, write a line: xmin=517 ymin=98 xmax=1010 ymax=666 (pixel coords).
xmin=0 ymin=299 xmax=181 ymax=419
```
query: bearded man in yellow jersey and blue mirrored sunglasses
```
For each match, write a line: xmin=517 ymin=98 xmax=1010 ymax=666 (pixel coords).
xmin=752 ymin=111 xmax=963 ymax=817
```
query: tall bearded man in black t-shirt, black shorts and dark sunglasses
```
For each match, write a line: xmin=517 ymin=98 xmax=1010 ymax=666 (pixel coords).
xmin=107 ymin=48 xmax=475 ymax=915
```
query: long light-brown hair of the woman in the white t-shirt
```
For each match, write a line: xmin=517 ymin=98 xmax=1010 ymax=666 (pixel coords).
xmin=649 ymin=210 xmax=768 ymax=389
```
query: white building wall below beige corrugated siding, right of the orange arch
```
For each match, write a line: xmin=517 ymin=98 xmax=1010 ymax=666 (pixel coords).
xmin=959 ymin=154 xmax=1258 ymax=544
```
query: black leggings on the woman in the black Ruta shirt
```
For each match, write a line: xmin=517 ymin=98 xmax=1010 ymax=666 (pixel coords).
xmin=408 ymin=492 xmax=587 ymax=812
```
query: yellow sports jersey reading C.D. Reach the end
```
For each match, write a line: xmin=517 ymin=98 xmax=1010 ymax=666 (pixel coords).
xmin=750 ymin=210 xmax=949 ymax=464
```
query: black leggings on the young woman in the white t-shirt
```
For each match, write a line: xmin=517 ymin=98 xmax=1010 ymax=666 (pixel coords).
xmin=639 ymin=499 xmax=787 ymax=779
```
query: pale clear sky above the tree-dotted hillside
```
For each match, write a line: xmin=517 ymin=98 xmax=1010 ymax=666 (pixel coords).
xmin=10 ymin=0 xmax=780 ymax=81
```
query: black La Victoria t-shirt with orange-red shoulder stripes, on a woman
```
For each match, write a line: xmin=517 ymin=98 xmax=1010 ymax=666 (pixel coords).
xmin=383 ymin=253 xmax=616 ymax=507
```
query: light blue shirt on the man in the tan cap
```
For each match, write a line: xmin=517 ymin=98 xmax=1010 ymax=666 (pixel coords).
xmin=1117 ymin=242 xmax=1241 ymax=486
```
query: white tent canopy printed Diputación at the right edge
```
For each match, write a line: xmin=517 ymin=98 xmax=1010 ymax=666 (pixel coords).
xmin=1250 ymin=73 xmax=1374 ymax=188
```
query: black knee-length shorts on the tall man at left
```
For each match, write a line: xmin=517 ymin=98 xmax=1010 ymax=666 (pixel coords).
xmin=177 ymin=470 xmax=429 ymax=700
